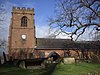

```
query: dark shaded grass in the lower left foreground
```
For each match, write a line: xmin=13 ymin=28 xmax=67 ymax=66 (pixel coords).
xmin=0 ymin=65 xmax=45 ymax=75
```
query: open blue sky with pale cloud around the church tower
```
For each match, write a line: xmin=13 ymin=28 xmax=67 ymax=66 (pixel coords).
xmin=0 ymin=0 xmax=92 ymax=40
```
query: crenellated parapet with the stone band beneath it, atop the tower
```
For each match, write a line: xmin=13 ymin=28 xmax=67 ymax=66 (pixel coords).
xmin=12 ymin=7 xmax=34 ymax=14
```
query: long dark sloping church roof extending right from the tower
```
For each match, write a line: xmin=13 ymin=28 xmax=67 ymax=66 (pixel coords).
xmin=36 ymin=38 xmax=100 ymax=50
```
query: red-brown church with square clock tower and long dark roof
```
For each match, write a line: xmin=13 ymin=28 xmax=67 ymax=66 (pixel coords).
xmin=8 ymin=7 xmax=99 ymax=59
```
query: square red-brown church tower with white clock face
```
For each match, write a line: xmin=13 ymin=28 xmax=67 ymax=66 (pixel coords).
xmin=8 ymin=7 xmax=36 ymax=58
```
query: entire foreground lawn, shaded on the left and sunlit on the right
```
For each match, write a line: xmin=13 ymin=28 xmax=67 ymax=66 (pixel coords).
xmin=0 ymin=63 xmax=100 ymax=75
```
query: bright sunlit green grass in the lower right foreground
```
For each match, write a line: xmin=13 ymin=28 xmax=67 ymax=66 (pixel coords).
xmin=52 ymin=63 xmax=100 ymax=75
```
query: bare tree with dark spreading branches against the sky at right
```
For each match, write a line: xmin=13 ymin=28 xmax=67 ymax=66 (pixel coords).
xmin=49 ymin=0 xmax=100 ymax=40
